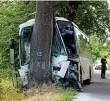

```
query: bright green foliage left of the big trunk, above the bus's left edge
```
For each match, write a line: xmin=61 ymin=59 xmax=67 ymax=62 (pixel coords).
xmin=0 ymin=1 xmax=36 ymax=68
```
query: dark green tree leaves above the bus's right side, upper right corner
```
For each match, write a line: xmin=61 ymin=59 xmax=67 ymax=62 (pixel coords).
xmin=75 ymin=1 xmax=110 ymax=41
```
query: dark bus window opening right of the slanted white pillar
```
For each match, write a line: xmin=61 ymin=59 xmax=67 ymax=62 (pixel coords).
xmin=57 ymin=20 xmax=77 ymax=56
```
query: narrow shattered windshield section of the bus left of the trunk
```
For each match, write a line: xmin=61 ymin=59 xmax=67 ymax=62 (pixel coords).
xmin=20 ymin=26 xmax=33 ymax=66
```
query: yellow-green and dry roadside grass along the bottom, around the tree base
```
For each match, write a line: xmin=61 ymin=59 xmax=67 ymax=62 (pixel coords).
xmin=0 ymin=69 xmax=76 ymax=101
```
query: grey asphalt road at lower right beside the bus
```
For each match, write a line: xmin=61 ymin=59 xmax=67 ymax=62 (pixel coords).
xmin=72 ymin=70 xmax=110 ymax=101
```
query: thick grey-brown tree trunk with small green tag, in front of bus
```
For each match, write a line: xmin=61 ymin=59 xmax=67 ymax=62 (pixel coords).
xmin=30 ymin=1 xmax=53 ymax=84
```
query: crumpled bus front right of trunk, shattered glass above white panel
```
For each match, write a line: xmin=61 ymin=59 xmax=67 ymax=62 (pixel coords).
xmin=52 ymin=24 xmax=69 ymax=78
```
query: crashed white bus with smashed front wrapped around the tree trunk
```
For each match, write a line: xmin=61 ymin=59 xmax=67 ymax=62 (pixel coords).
xmin=19 ymin=17 xmax=93 ymax=90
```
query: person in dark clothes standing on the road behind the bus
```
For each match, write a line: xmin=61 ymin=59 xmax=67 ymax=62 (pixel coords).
xmin=101 ymin=56 xmax=107 ymax=78
